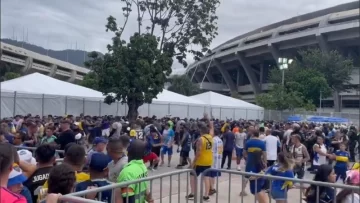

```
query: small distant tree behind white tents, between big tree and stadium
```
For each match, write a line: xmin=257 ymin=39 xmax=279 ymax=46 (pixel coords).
xmin=168 ymin=74 xmax=201 ymax=96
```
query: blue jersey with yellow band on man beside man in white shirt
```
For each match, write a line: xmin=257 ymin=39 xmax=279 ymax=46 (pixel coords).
xmin=244 ymin=139 xmax=266 ymax=173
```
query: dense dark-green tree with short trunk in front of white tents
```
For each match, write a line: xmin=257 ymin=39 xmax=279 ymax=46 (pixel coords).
xmin=86 ymin=33 xmax=173 ymax=121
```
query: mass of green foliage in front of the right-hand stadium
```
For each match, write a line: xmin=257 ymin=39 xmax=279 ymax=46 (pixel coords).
xmin=256 ymin=49 xmax=353 ymax=110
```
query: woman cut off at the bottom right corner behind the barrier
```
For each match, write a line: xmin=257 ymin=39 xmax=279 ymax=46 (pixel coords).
xmin=336 ymin=170 xmax=360 ymax=203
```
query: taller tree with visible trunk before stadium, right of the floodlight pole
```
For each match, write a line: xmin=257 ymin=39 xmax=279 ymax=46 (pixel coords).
xmin=299 ymin=49 xmax=354 ymax=111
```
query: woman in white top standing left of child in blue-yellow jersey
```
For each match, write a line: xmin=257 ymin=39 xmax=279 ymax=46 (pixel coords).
xmin=312 ymin=136 xmax=330 ymax=171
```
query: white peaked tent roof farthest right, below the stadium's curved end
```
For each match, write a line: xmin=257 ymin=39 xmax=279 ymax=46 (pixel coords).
xmin=190 ymin=91 xmax=264 ymax=110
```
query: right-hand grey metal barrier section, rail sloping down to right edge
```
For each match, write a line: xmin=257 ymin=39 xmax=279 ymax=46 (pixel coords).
xmin=199 ymin=169 xmax=360 ymax=203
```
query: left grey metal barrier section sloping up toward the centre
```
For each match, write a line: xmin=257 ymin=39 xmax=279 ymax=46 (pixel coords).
xmin=60 ymin=169 xmax=197 ymax=203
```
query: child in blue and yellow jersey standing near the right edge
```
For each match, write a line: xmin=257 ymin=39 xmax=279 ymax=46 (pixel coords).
xmin=334 ymin=143 xmax=350 ymax=183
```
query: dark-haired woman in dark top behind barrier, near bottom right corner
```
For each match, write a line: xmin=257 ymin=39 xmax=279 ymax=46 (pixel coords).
xmin=305 ymin=164 xmax=336 ymax=203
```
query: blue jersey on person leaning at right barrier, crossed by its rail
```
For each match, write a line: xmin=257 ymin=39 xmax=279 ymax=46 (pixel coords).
xmin=266 ymin=164 xmax=294 ymax=191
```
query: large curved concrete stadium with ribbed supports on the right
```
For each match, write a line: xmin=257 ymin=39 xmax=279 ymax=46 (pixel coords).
xmin=187 ymin=1 xmax=360 ymax=111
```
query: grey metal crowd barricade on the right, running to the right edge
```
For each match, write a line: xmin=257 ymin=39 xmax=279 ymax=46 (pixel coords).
xmin=199 ymin=169 xmax=360 ymax=203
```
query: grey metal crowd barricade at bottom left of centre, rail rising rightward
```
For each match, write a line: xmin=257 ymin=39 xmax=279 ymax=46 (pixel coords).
xmin=60 ymin=169 xmax=198 ymax=203
